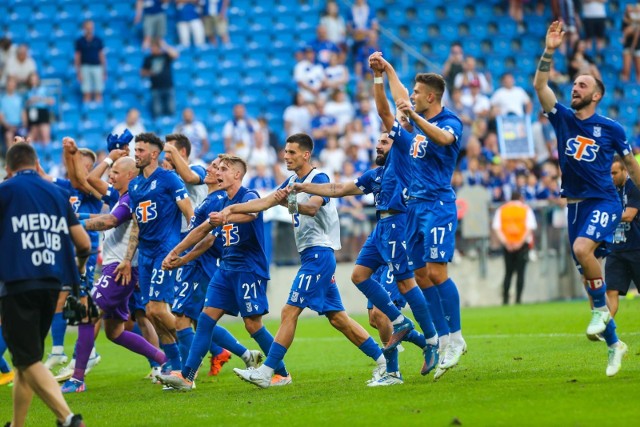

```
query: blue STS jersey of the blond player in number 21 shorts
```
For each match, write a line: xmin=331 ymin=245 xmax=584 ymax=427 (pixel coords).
xmin=215 ymin=187 xmax=269 ymax=279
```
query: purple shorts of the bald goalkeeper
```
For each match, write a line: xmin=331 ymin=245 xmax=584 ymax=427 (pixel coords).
xmin=91 ymin=262 xmax=138 ymax=321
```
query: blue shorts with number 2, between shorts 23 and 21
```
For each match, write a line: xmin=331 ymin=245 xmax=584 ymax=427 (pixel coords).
xmin=171 ymin=263 xmax=211 ymax=320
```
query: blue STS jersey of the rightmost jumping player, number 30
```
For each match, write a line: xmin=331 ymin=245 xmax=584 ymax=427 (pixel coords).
xmin=547 ymin=103 xmax=631 ymax=200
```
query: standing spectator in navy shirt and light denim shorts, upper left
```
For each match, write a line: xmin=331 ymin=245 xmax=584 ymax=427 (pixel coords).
xmin=74 ymin=20 xmax=107 ymax=103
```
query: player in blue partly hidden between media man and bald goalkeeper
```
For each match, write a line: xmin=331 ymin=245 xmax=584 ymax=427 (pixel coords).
xmin=45 ymin=137 xmax=103 ymax=380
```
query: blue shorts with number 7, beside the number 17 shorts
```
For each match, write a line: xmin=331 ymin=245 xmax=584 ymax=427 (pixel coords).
xmin=356 ymin=214 xmax=413 ymax=280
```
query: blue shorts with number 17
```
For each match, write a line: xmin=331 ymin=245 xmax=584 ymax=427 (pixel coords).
xmin=405 ymin=199 xmax=458 ymax=270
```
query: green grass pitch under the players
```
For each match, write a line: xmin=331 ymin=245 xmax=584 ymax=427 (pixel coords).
xmin=0 ymin=298 xmax=640 ymax=427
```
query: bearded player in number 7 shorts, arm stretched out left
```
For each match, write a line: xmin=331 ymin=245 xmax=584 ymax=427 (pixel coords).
xmin=293 ymin=133 xmax=438 ymax=384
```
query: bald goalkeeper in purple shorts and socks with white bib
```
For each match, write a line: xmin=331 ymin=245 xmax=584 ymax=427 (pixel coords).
xmin=62 ymin=157 xmax=167 ymax=393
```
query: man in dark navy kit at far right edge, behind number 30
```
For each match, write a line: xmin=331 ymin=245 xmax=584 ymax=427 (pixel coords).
xmin=604 ymin=156 xmax=640 ymax=317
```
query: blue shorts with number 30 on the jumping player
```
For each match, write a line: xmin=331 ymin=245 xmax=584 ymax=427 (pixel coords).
xmin=567 ymin=199 xmax=622 ymax=274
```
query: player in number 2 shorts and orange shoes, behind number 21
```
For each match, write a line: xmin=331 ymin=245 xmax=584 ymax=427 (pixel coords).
xmin=171 ymin=157 xmax=262 ymax=376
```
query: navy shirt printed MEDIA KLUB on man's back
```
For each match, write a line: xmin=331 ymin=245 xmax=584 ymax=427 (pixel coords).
xmin=0 ymin=170 xmax=80 ymax=297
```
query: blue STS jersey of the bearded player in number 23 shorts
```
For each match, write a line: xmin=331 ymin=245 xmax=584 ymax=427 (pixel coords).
xmin=129 ymin=168 xmax=189 ymax=257
